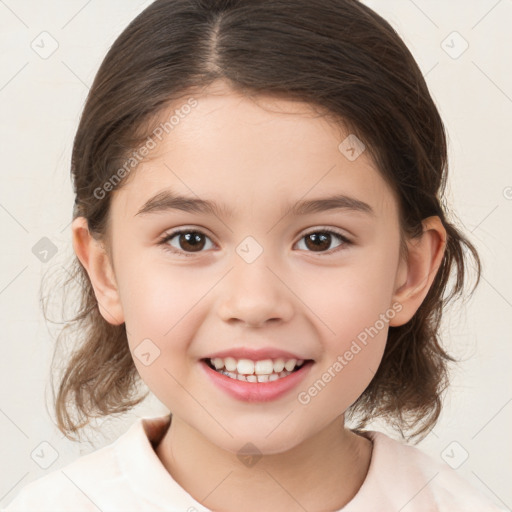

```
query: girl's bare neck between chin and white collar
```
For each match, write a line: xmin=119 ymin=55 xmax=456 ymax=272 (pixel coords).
xmin=156 ymin=416 xmax=372 ymax=512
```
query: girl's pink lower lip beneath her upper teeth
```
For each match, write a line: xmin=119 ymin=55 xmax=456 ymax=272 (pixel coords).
xmin=201 ymin=361 xmax=313 ymax=402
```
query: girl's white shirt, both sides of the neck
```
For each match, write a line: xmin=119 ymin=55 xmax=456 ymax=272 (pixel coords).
xmin=2 ymin=415 xmax=504 ymax=512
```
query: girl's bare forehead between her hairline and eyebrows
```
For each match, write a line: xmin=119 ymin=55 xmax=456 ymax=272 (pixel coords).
xmin=112 ymin=86 xmax=396 ymax=222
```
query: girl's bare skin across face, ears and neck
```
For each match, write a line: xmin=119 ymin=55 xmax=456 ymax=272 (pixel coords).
xmin=72 ymin=82 xmax=446 ymax=512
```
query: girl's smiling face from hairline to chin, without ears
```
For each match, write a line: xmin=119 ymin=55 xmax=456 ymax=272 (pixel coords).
xmin=101 ymin=80 xmax=400 ymax=453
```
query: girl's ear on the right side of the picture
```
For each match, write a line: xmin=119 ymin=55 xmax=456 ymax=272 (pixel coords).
xmin=389 ymin=216 xmax=446 ymax=327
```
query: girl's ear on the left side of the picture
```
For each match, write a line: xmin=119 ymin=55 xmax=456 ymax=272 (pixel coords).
xmin=71 ymin=217 xmax=124 ymax=325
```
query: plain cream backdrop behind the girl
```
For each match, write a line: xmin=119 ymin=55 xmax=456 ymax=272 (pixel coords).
xmin=0 ymin=0 xmax=512 ymax=509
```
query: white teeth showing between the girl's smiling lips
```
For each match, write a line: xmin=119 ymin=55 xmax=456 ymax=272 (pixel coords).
xmin=202 ymin=357 xmax=313 ymax=383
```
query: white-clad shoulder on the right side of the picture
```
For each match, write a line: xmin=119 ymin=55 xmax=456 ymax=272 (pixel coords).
xmin=347 ymin=432 xmax=501 ymax=512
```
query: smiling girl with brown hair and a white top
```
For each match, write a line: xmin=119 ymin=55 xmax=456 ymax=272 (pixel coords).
xmin=5 ymin=0 xmax=506 ymax=512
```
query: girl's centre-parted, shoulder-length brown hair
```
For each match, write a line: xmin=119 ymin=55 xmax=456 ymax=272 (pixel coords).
xmin=43 ymin=0 xmax=481 ymax=439
